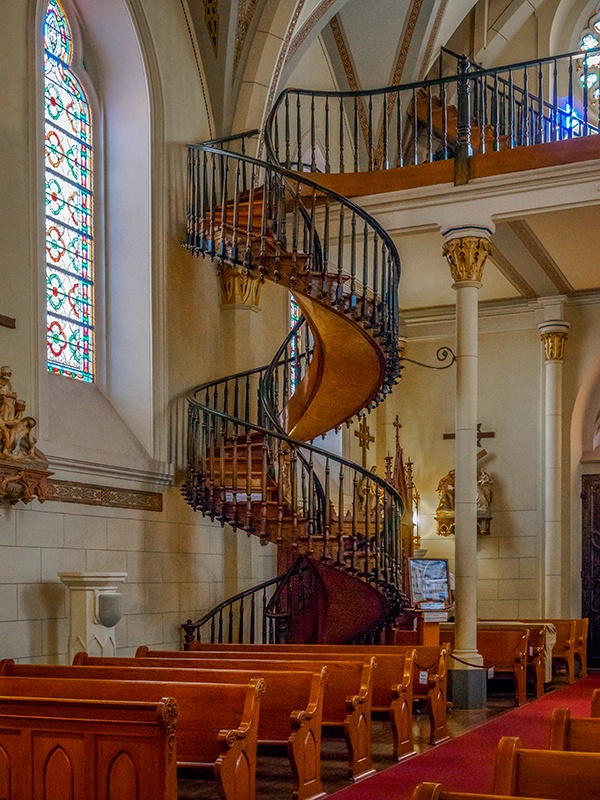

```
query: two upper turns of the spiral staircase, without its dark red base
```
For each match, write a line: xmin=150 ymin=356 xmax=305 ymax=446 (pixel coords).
xmin=183 ymin=131 xmax=403 ymax=635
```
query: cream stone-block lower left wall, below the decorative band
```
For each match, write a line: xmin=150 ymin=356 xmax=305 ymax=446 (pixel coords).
xmin=0 ymin=489 xmax=274 ymax=663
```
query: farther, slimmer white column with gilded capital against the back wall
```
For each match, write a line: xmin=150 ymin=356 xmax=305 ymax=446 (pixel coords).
xmin=538 ymin=320 xmax=569 ymax=617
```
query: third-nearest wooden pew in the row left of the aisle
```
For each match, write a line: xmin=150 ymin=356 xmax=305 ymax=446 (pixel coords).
xmin=0 ymin=654 xmax=327 ymax=800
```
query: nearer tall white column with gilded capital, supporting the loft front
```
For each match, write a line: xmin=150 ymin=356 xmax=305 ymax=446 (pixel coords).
xmin=444 ymin=228 xmax=491 ymax=708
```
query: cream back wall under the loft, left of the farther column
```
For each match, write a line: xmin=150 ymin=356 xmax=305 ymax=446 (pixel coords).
xmin=377 ymin=302 xmax=543 ymax=618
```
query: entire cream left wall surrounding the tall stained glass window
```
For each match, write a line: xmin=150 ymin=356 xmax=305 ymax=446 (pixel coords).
xmin=0 ymin=0 xmax=278 ymax=662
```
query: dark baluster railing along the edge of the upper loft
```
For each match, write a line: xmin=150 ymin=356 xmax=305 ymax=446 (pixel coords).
xmin=265 ymin=48 xmax=600 ymax=173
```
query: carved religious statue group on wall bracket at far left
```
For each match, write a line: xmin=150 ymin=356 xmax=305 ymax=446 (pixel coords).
xmin=0 ymin=366 xmax=51 ymax=504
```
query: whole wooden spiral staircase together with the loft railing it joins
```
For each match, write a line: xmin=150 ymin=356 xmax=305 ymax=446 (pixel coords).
xmin=182 ymin=48 xmax=598 ymax=641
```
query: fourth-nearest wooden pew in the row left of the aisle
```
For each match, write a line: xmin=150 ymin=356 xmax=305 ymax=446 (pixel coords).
xmin=74 ymin=651 xmax=376 ymax=781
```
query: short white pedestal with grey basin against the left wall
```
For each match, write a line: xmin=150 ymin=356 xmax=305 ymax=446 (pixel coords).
xmin=58 ymin=572 xmax=127 ymax=664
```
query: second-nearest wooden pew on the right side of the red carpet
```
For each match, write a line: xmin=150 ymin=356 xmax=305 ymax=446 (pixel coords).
xmin=492 ymin=736 xmax=600 ymax=800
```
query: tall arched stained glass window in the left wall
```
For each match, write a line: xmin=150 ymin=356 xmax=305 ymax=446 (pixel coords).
xmin=44 ymin=0 xmax=94 ymax=381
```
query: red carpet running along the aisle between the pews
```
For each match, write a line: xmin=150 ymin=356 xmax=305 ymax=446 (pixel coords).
xmin=330 ymin=674 xmax=600 ymax=800
